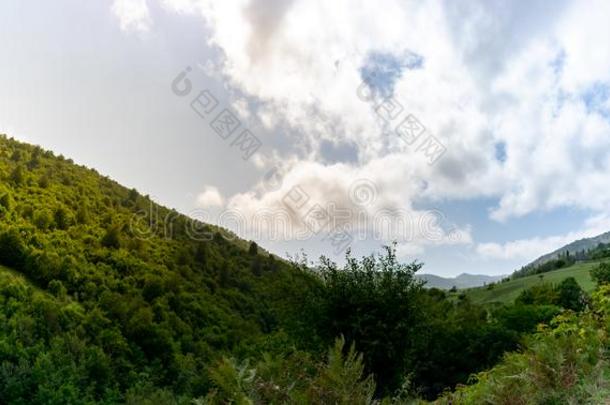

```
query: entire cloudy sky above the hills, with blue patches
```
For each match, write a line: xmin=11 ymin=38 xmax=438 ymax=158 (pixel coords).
xmin=0 ymin=0 xmax=610 ymax=276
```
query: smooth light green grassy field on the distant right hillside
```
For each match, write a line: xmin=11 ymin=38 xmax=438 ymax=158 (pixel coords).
xmin=464 ymin=261 xmax=600 ymax=304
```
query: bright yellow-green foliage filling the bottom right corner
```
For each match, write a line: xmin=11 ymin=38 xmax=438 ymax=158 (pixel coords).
xmin=438 ymin=287 xmax=610 ymax=404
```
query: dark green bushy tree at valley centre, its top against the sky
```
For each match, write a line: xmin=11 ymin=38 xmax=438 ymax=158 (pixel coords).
xmin=308 ymin=246 xmax=423 ymax=392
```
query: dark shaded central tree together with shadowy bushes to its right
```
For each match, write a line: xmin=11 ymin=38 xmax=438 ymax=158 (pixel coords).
xmin=305 ymin=246 xmax=558 ymax=398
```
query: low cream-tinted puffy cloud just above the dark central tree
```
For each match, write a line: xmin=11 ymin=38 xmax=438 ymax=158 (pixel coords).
xmin=220 ymin=155 xmax=472 ymax=251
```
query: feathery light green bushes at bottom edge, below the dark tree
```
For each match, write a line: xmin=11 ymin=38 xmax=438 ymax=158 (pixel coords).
xmin=200 ymin=338 xmax=375 ymax=405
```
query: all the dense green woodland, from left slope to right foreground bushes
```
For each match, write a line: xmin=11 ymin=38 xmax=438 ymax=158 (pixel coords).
xmin=0 ymin=136 xmax=610 ymax=404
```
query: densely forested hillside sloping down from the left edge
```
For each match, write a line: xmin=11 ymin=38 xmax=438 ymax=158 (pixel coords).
xmin=0 ymin=136 xmax=318 ymax=404
